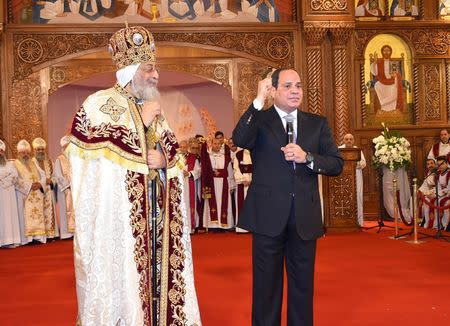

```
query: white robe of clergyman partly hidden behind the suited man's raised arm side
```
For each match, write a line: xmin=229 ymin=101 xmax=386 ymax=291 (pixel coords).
xmin=233 ymin=149 xmax=252 ymax=233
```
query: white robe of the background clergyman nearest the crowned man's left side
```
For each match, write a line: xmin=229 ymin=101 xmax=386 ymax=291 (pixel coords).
xmin=53 ymin=154 xmax=75 ymax=239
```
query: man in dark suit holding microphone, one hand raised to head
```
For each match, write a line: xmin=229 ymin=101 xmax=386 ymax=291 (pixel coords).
xmin=233 ymin=69 xmax=343 ymax=326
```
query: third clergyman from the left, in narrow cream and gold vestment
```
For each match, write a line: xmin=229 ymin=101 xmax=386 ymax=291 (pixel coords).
xmin=31 ymin=138 xmax=60 ymax=238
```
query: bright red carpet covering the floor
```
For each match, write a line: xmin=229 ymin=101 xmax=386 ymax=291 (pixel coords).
xmin=0 ymin=229 xmax=450 ymax=326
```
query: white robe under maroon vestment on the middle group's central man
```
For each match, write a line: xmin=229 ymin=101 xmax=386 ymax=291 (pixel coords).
xmin=203 ymin=151 xmax=235 ymax=229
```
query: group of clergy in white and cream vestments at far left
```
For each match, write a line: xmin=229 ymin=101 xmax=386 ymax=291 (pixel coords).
xmin=0 ymin=137 xmax=75 ymax=247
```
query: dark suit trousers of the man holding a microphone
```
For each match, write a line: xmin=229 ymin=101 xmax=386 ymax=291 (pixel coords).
xmin=252 ymin=200 xmax=316 ymax=326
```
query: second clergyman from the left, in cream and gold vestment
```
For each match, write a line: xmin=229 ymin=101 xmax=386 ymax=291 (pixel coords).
xmin=14 ymin=139 xmax=47 ymax=244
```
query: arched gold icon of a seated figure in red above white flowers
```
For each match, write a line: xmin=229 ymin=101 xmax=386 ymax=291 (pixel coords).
xmin=362 ymin=34 xmax=413 ymax=126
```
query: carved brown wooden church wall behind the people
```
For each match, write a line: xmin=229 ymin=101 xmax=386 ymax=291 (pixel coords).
xmin=0 ymin=0 xmax=450 ymax=222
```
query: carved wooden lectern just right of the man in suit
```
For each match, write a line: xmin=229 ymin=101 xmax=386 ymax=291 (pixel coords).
xmin=325 ymin=148 xmax=361 ymax=231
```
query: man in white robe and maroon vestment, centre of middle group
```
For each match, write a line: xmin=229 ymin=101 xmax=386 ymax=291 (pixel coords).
xmin=202 ymin=138 xmax=235 ymax=229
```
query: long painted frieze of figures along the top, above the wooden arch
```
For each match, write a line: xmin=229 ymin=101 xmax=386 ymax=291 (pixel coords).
xmin=7 ymin=0 xmax=297 ymax=24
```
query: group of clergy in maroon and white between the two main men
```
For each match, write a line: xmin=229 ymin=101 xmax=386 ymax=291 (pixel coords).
xmin=179 ymin=131 xmax=252 ymax=233
